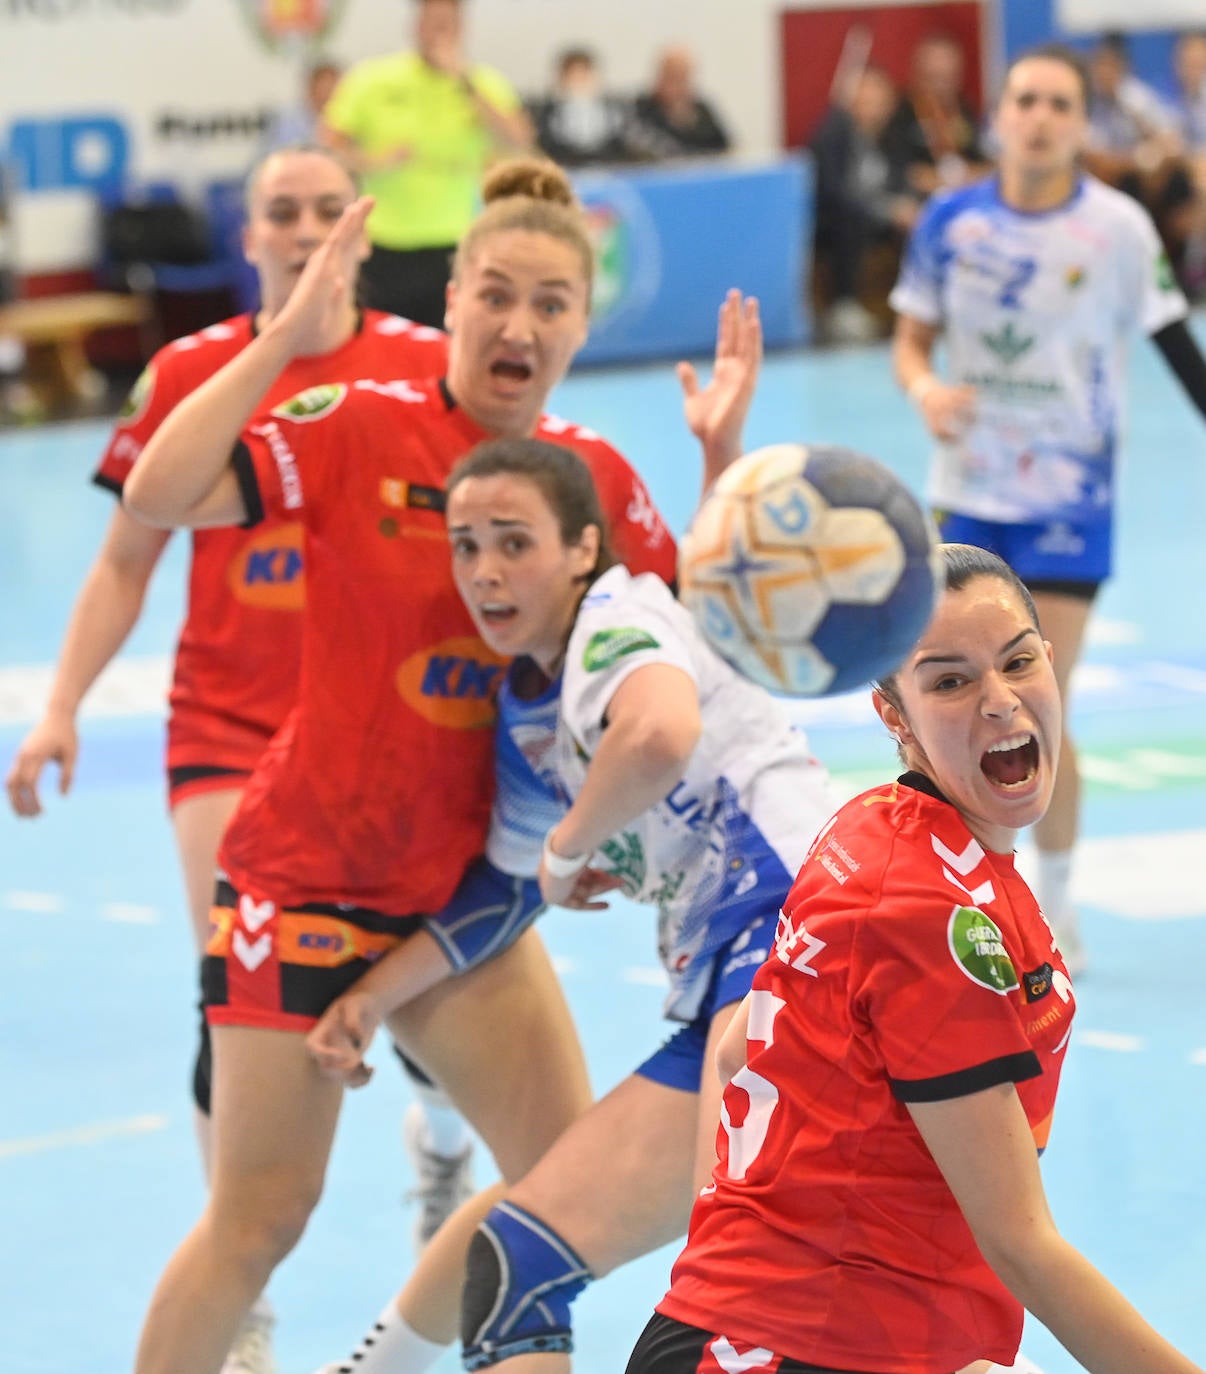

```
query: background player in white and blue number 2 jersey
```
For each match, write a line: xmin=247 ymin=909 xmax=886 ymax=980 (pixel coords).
xmin=891 ymin=45 xmax=1206 ymax=969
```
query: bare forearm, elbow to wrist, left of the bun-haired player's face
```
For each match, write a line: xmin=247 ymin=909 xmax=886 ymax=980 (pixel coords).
xmin=122 ymin=323 xmax=294 ymax=526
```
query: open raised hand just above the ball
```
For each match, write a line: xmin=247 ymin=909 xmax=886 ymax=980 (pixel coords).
xmin=676 ymin=290 xmax=762 ymax=495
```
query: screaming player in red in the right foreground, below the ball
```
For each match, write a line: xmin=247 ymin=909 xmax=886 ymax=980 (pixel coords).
xmin=628 ymin=544 xmax=1201 ymax=1374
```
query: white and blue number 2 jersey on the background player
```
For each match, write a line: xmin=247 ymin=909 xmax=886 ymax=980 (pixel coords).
xmin=891 ymin=176 xmax=1188 ymax=523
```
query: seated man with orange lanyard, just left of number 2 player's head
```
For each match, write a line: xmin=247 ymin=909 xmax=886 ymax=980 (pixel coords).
xmin=883 ymin=33 xmax=990 ymax=202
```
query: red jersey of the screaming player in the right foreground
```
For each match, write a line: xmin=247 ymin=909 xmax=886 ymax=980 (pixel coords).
xmin=658 ymin=774 xmax=1074 ymax=1374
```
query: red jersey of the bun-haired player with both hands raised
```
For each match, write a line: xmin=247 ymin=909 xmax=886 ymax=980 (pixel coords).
xmin=218 ymin=382 xmax=674 ymax=915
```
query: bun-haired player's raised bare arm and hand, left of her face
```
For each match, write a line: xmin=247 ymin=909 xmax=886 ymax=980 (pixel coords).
xmin=124 ymin=196 xmax=372 ymax=528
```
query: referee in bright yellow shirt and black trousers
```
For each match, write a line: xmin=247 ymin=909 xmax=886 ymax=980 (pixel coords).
xmin=323 ymin=0 xmax=532 ymax=327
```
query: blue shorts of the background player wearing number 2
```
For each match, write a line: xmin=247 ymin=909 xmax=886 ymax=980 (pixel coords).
xmin=934 ymin=510 xmax=1114 ymax=595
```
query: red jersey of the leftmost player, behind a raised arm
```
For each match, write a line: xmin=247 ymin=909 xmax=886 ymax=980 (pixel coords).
xmin=93 ymin=311 xmax=448 ymax=772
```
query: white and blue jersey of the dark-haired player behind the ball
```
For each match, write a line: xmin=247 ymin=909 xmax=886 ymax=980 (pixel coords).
xmin=544 ymin=567 xmax=835 ymax=1021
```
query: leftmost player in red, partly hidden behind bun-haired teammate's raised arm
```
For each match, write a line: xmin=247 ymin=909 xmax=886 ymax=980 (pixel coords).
xmin=7 ymin=147 xmax=468 ymax=1374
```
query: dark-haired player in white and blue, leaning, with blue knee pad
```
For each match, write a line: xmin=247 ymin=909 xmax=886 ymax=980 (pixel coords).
xmin=310 ymin=440 xmax=834 ymax=1374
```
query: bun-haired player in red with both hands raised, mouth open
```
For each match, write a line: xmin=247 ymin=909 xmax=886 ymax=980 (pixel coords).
xmin=118 ymin=162 xmax=757 ymax=1374
